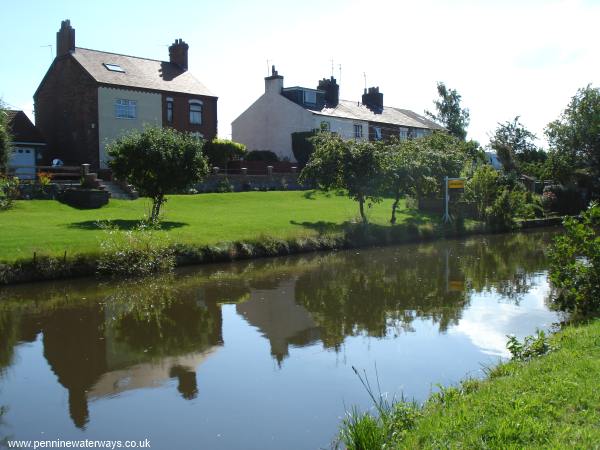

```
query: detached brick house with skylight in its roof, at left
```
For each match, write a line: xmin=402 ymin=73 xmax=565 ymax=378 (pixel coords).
xmin=33 ymin=20 xmax=217 ymax=170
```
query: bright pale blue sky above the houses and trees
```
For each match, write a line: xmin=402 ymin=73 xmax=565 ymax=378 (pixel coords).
xmin=0 ymin=0 xmax=600 ymax=144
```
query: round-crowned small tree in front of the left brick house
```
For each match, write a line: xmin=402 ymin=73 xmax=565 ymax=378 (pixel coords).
xmin=107 ymin=127 xmax=208 ymax=222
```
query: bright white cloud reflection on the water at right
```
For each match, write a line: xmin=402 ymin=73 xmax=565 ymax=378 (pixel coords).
xmin=449 ymin=280 xmax=558 ymax=357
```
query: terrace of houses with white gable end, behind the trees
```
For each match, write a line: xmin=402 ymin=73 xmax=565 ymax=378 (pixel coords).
xmin=231 ymin=67 xmax=444 ymax=160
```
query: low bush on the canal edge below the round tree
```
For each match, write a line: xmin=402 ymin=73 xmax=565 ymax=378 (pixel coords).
xmin=97 ymin=222 xmax=175 ymax=277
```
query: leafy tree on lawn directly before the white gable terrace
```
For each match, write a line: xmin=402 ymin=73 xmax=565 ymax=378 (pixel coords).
xmin=300 ymin=133 xmax=383 ymax=223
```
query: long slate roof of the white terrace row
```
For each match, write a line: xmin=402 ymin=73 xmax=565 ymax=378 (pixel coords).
xmin=309 ymin=100 xmax=445 ymax=130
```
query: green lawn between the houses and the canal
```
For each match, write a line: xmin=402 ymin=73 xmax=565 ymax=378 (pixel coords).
xmin=0 ymin=191 xmax=430 ymax=262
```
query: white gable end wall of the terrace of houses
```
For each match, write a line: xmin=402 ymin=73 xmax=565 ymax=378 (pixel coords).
xmin=231 ymin=90 xmax=315 ymax=161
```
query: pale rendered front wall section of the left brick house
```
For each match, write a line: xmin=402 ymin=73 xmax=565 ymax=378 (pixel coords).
xmin=98 ymin=87 xmax=162 ymax=168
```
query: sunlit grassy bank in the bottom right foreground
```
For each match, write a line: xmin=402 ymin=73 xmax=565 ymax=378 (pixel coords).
xmin=343 ymin=319 xmax=600 ymax=449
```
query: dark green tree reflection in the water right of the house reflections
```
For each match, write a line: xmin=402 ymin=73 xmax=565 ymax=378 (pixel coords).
xmin=296 ymin=230 xmax=549 ymax=347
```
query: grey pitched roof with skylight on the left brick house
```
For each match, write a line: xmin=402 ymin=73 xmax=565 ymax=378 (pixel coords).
xmin=71 ymin=47 xmax=214 ymax=97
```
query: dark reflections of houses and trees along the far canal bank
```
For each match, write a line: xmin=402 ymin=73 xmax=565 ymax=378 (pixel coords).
xmin=0 ymin=229 xmax=550 ymax=436
